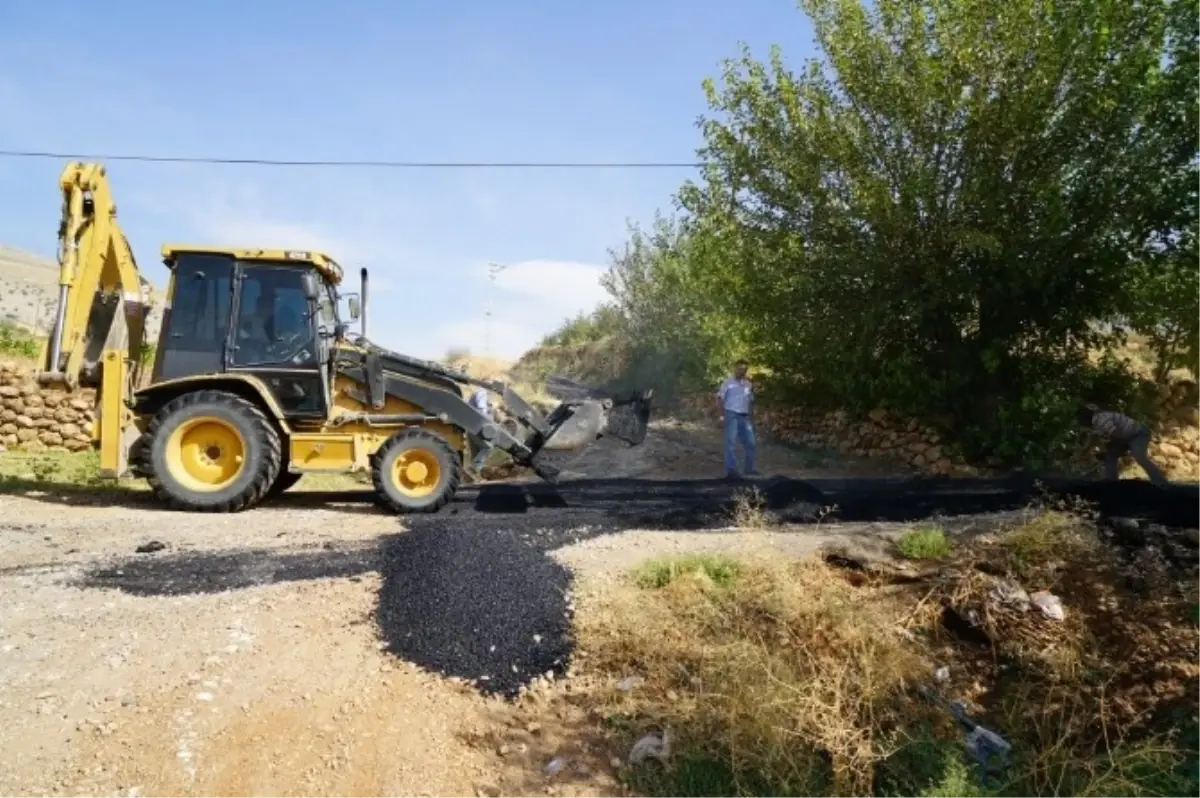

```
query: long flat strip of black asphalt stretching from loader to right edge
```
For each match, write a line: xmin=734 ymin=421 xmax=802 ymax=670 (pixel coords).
xmin=439 ymin=476 xmax=1200 ymax=539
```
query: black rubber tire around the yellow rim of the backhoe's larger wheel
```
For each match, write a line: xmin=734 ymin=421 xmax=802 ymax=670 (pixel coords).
xmin=138 ymin=390 xmax=283 ymax=512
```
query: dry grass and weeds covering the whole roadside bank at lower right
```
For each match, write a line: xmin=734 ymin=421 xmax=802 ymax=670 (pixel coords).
xmin=576 ymin=502 xmax=1200 ymax=798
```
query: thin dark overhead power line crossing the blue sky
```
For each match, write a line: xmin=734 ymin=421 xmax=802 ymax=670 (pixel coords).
xmin=0 ymin=150 xmax=701 ymax=169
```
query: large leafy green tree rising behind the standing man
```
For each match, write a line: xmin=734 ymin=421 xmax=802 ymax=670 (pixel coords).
xmin=679 ymin=0 xmax=1200 ymax=457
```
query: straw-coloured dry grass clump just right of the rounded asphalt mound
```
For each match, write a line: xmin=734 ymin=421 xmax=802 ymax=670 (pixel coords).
xmin=578 ymin=552 xmax=925 ymax=794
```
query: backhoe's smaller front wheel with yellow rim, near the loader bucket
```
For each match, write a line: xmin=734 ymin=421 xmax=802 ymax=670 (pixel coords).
xmin=371 ymin=428 xmax=462 ymax=514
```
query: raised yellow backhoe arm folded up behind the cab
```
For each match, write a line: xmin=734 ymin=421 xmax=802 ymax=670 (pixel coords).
xmin=37 ymin=163 xmax=150 ymax=478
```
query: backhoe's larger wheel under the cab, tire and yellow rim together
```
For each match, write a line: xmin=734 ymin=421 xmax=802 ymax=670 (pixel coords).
xmin=142 ymin=390 xmax=283 ymax=512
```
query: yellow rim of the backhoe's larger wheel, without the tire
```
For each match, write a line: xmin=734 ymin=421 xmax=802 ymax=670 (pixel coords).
xmin=166 ymin=416 xmax=246 ymax=493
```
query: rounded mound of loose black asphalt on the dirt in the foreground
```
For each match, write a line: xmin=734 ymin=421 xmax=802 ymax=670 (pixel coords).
xmin=378 ymin=527 xmax=571 ymax=697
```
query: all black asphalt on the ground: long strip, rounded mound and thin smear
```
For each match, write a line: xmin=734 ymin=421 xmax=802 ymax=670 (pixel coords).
xmin=77 ymin=478 xmax=1200 ymax=696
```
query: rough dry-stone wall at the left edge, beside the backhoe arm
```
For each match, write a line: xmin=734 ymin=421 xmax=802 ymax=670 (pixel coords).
xmin=0 ymin=362 xmax=96 ymax=451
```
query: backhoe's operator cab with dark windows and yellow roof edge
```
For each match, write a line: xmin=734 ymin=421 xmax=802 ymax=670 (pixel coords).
xmin=151 ymin=247 xmax=341 ymax=419
